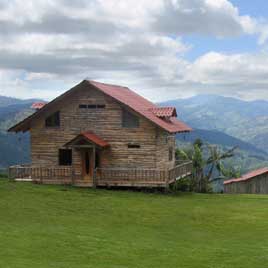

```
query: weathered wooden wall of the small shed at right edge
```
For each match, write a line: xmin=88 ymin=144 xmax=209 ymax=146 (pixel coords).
xmin=224 ymin=174 xmax=268 ymax=194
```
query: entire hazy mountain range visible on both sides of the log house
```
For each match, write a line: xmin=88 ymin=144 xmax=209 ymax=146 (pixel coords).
xmin=0 ymin=95 xmax=268 ymax=173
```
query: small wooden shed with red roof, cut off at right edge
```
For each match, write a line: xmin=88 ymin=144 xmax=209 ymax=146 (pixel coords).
xmin=224 ymin=168 xmax=268 ymax=194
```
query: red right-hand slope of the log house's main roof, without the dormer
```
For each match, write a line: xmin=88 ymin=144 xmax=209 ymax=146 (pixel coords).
xmin=87 ymin=80 xmax=192 ymax=133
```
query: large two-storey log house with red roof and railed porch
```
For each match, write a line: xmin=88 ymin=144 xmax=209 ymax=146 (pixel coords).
xmin=9 ymin=80 xmax=191 ymax=187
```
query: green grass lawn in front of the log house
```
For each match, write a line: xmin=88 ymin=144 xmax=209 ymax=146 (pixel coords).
xmin=0 ymin=180 xmax=268 ymax=268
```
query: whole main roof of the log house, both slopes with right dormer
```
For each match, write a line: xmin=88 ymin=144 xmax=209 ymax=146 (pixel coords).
xmin=8 ymin=80 xmax=192 ymax=133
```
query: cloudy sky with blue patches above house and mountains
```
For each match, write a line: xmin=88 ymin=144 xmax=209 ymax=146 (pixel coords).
xmin=0 ymin=0 xmax=268 ymax=101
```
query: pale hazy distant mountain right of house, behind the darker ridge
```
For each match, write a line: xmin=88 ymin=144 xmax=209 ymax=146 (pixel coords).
xmin=161 ymin=95 xmax=268 ymax=152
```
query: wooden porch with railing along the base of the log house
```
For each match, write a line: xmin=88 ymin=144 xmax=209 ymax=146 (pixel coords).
xmin=9 ymin=161 xmax=192 ymax=188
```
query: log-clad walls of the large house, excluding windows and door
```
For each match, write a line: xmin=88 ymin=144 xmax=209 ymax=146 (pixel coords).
xmin=31 ymin=82 xmax=175 ymax=178
